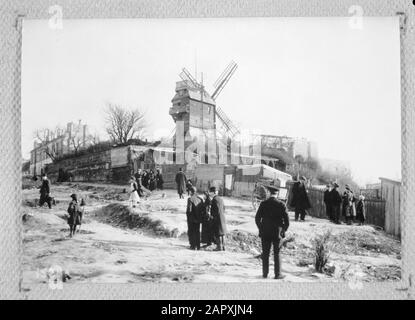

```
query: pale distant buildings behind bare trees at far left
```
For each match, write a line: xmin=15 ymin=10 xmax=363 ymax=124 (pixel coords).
xmin=29 ymin=121 xmax=91 ymax=176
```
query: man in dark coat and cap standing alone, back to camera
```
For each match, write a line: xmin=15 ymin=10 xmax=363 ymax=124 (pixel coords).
xmin=255 ymin=186 xmax=290 ymax=279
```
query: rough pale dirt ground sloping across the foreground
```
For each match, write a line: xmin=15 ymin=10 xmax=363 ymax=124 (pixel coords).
xmin=22 ymin=184 xmax=400 ymax=283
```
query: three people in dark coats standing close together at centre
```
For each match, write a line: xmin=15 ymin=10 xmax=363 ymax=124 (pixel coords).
xmin=186 ymin=186 xmax=227 ymax=251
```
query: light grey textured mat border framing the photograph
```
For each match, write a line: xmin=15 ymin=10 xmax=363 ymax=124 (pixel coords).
xmin=0 ymin=0 xmax=415 ymax=299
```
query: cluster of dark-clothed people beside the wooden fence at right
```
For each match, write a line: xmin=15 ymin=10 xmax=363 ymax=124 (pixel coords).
xmin=324 ymin=182 xmax=366 ymax=225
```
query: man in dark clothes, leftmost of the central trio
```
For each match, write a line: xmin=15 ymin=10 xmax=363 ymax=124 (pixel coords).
xmin=186 ymin=187 xmax=204 ymax=250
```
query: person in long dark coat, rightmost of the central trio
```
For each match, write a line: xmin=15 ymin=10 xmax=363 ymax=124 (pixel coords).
xmin=209 ymin=187 xmax=228 ymax=251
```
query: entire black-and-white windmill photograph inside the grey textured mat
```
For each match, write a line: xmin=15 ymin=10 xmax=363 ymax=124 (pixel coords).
xmin=21 ymin=13 xmax=402 ymax=286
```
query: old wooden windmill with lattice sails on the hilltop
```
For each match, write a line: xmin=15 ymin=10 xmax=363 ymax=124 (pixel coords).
xmin=169 ymin=61 xmax=239 ymax=163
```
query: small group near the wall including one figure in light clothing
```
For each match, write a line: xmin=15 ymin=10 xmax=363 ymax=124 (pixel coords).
xmin=130 ymin=169 xmax=164 ymax=207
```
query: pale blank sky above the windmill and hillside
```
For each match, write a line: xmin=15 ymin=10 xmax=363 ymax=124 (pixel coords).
xmin=22 ymin=18 xmax=401 ymax=183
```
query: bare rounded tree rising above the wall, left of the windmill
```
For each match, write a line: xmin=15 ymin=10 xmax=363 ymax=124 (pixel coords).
xmin=105 ymin=104 xmax=145 ymax=143
